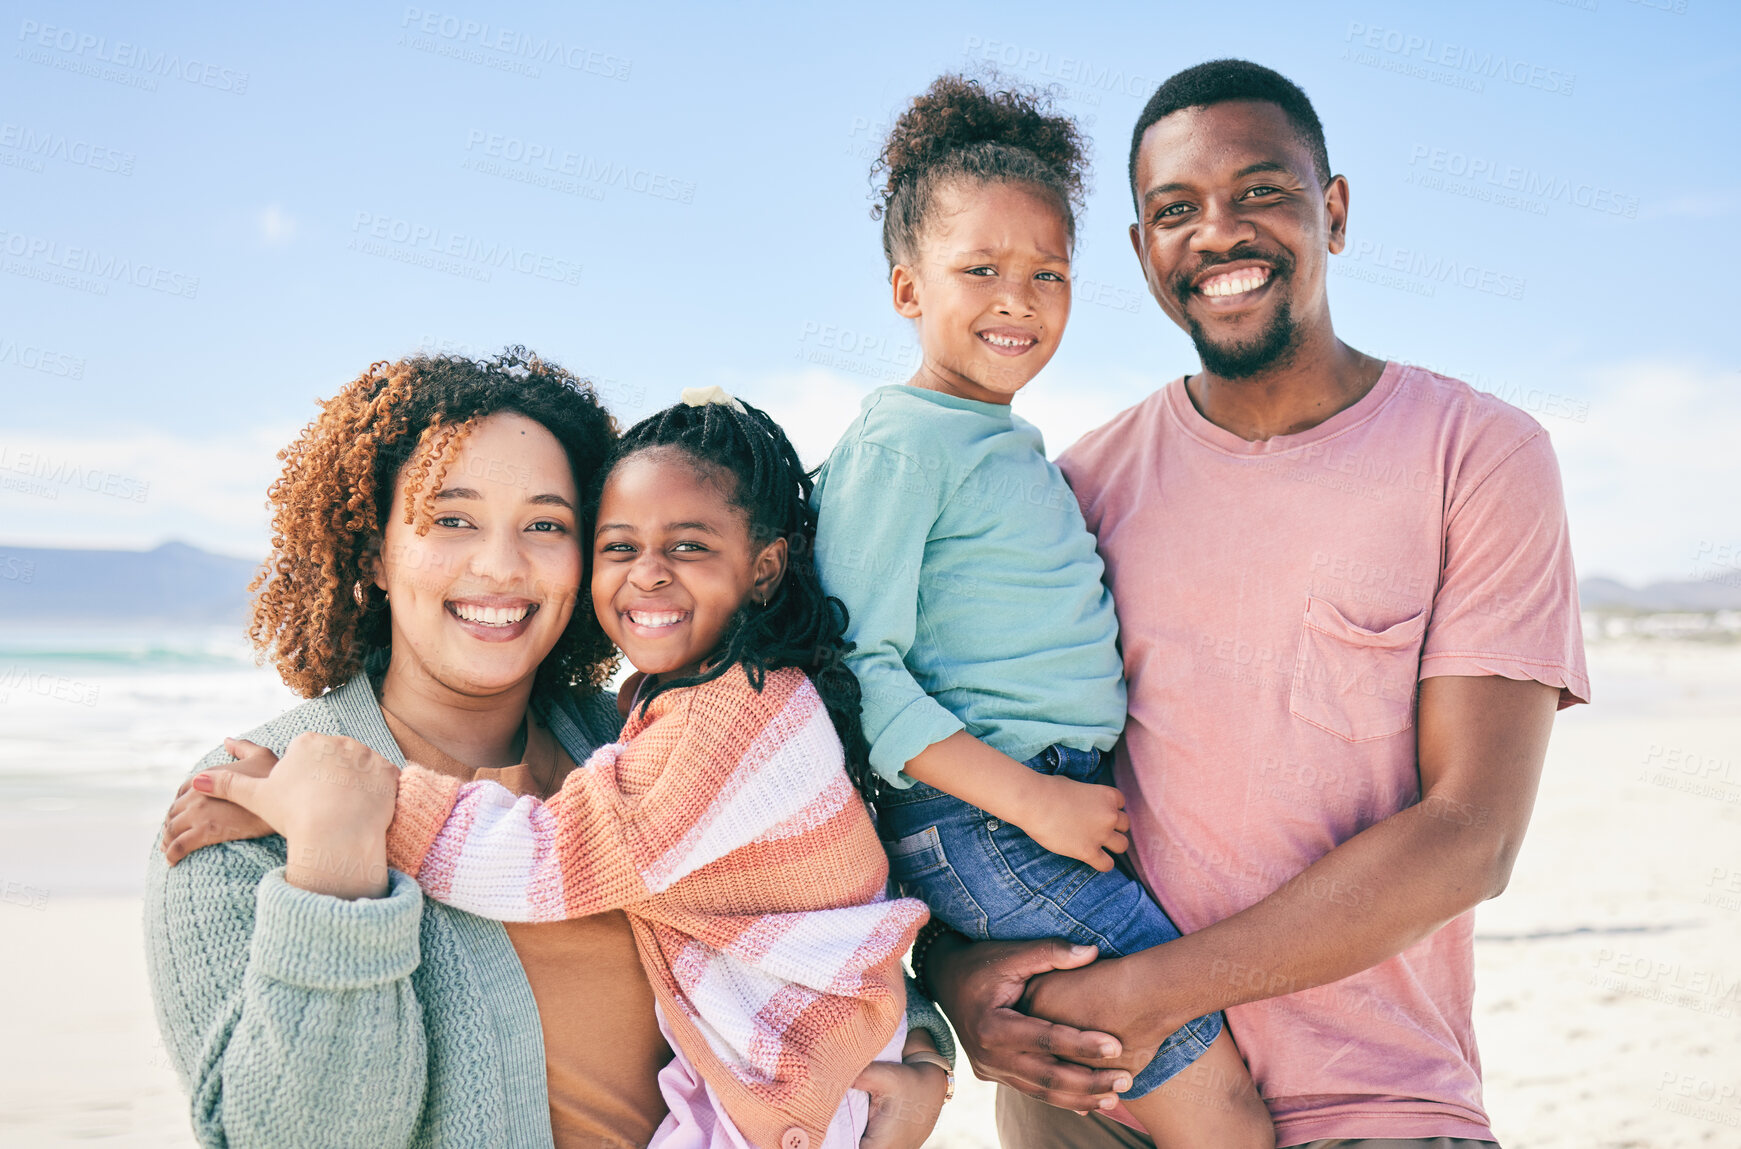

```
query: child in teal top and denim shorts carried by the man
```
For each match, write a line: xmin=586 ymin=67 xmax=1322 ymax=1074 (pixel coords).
xmin=815 ymin=77 xmax=1274 ymax=1147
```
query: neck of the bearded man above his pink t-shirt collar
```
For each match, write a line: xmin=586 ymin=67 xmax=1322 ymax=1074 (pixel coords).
xmin=1186 ymin=334 xmax=1384 ymax=442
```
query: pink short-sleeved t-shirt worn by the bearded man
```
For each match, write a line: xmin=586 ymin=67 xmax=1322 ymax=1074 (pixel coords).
xmin=1059 ymin=362 xmax=1590 ymax=1146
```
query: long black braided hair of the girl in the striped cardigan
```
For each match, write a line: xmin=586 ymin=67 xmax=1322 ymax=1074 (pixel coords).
xmin=602 ymin=399 xmax=872 ymax=792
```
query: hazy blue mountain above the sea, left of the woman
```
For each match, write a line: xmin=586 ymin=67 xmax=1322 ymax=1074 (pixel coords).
xmin=0 ymin=543 xmax=258 ymax=625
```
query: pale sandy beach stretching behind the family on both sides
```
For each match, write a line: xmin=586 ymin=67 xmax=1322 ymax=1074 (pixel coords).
xmin=0 ymin=642 xmax=1741 ymax=1149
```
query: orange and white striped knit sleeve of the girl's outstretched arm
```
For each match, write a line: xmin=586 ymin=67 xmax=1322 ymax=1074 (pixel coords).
xmin=387 ymin=670 xmax=850 ymax=921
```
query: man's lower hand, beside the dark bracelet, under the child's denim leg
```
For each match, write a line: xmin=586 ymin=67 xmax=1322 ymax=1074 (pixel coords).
xmin=924 ymin=933 xmax=1132 ymax=1112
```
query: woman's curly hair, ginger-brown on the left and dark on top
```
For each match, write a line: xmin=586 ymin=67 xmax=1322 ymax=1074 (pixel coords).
xmin=247 ymin=346 xmax=616 ymax=698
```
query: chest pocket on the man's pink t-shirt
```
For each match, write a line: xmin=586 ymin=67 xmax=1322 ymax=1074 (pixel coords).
xmin=1288 ymin=597 xmax=1428 ymax=742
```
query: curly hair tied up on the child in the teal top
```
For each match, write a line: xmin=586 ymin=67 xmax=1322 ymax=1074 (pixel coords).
xmin=871 ymin=73 xmax=1088 ymax=270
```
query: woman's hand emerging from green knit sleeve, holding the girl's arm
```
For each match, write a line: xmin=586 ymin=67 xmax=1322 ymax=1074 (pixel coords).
xmin=192 ymin=733 xmax=399 ymax=898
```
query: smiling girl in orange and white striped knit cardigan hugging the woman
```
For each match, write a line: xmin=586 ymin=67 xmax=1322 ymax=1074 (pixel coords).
xmin=377 ymin=388 xmax=935 ymax=1149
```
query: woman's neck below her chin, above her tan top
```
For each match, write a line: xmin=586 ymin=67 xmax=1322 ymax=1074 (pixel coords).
xmin=381 ymin=648 xmax=533 ymax=769
